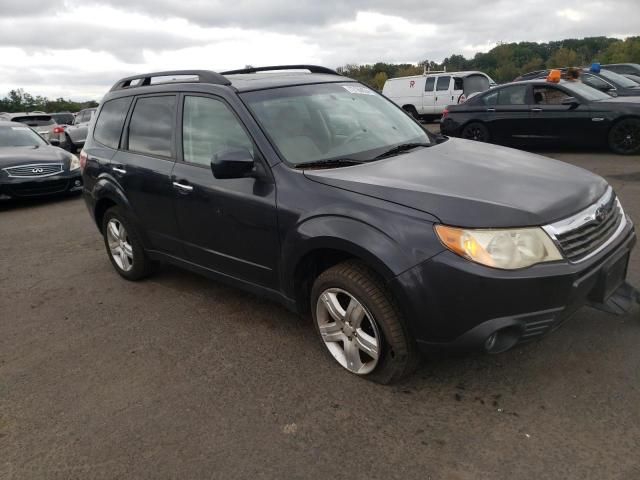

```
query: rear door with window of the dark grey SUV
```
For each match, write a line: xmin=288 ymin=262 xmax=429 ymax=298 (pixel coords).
xmin=110 ymin=94 xmax=184 ymax=257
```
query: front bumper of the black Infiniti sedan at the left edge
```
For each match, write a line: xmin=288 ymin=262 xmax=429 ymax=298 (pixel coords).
xmin=0 ymin=170 xmax=82 ymax=200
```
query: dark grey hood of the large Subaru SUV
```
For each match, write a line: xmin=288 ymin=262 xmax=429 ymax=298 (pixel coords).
xmin=304 ymin=139 xmax=607 ymax=228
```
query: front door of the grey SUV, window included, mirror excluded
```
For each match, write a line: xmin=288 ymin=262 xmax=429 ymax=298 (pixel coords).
xmin=172 ymin=94 xmax=279 ymax=288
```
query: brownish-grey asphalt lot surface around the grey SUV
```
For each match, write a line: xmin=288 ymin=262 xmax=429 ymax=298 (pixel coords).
xmin=0 ymin=148 xmax=640 ymax=480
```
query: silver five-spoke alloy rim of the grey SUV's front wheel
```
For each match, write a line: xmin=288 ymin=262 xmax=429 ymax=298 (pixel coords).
xmin=316 ymin=288 xmax=382 ymax=375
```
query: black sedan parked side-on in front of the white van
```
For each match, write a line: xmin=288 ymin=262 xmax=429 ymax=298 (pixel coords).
xmin=441 ymin=80 xmax=640 ymax=155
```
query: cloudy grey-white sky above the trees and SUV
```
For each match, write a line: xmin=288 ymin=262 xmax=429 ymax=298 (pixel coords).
xmin=0 ymin=0 xmax=640 ymax=100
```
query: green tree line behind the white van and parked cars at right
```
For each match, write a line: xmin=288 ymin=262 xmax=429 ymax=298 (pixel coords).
xmin=338 ymin=37 xmax=640 ymax=90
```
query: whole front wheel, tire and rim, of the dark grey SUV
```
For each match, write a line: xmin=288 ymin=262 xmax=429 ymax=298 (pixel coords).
xmin=311 ymin=260 xmax=420 ymax=384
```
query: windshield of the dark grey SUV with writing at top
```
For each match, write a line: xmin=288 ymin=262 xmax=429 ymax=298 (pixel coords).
xmin=242 ymin=83 xmax=431 ymax=166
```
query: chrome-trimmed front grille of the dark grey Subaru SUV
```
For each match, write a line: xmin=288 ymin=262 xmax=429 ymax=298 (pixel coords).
xmin=544 ymin=187 xmax=626 ymax=263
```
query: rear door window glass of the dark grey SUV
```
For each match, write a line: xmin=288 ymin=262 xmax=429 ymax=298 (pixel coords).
xmin=129 ymin=95 xmax=176 ymax=158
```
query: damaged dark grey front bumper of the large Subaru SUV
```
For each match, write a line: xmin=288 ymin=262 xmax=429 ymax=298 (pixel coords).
xmin=391 ymin=220 xmax=637 ymax=351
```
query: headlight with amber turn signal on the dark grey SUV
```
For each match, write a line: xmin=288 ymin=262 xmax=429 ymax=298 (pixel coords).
xmin=436 ymin=225 xmax=562 ymax=270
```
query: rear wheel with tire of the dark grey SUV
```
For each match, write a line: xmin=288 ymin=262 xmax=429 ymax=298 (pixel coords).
xmin=102 ymin=206 xmax=152 ymax=281
